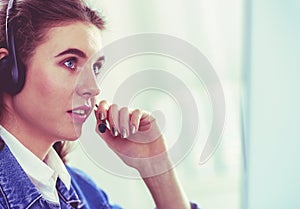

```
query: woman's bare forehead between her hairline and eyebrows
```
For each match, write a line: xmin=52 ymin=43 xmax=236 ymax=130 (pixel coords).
xmin=36 ymin=22 xmax=103 ymax=57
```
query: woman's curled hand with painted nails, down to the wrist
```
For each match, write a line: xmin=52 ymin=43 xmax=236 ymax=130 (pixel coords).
xmin=95 ymin=101 xmax=170 ymax=176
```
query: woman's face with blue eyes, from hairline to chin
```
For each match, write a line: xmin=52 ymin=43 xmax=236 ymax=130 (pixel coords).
xmin=12 ymin=22 xmax=103 ymax=140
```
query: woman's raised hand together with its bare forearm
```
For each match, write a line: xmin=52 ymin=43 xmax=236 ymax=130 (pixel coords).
xmin=95 ymin=101 xmax=190 ymax=209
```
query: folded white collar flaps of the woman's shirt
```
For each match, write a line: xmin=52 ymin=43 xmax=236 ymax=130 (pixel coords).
xmin=0 ymin=125 xmax=71 ymax=190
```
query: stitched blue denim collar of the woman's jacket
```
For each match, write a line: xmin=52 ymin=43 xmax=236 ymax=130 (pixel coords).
xmin=0 ymin=136 xmax=82 ymax=208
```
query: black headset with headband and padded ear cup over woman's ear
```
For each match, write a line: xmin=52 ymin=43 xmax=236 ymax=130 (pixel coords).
xmin=0 ymin=0 xmax=26 ymax=95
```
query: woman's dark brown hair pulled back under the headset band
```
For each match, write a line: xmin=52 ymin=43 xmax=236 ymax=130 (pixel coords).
xmin=0 ymin=0 xmax=104 ymax=162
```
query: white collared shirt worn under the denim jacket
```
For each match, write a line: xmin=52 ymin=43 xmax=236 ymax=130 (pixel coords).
xmin=0 ymin=125 xmax=71 ymax=203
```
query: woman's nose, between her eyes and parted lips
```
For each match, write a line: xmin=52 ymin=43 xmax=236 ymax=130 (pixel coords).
xmin=76 ymin=68 xmax=100 ymax=98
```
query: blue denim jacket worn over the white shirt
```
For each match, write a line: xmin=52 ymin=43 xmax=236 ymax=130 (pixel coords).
xmin=0 ymin=137 xmax=198 ymax=209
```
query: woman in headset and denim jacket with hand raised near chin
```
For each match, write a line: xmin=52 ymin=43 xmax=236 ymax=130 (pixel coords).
xmin=0 ymin=0 xmax=202 ymax=209
